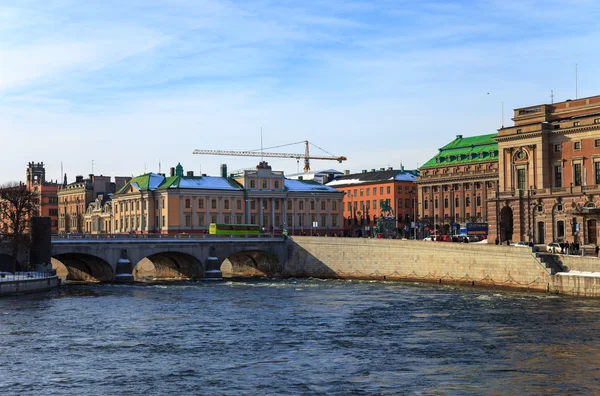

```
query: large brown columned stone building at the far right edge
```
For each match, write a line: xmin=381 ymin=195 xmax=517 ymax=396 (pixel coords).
xmin=489 ymin=96 xmax=600 ymax=244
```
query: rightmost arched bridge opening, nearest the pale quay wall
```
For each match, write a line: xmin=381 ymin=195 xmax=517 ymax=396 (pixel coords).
xmin=221 ymin=250 xmax=281 ymax=278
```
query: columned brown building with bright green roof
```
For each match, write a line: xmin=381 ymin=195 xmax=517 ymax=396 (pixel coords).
xmin=417 ymin=133 xmax=498 ymax=235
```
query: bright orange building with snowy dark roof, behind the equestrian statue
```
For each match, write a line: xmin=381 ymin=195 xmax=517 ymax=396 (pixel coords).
xmin=327 ymin=168 xmax=418 ymax=237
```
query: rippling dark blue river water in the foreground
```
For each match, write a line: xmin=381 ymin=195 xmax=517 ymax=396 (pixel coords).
xmin=0 ymin=280 xmax=600 ymax=395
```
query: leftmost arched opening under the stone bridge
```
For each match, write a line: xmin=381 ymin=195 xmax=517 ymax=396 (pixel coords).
xmin=50 ymin=253 xmax=114 ymax=282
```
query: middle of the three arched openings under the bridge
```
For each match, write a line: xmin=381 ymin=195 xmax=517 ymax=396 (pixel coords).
xmin=132 ymin=252 xmax=204 ymax=282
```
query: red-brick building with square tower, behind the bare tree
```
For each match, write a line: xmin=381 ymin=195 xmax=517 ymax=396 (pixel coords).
xmin=26 ymin=162 xmax=59 ymax=233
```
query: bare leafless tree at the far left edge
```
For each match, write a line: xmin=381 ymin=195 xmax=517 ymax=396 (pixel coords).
xmin=0 ymin=182 xmax=39 ymax=272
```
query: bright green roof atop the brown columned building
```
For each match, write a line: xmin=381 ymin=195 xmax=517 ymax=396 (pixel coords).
xmin=421 ymin=133 xmax=498 ymax=169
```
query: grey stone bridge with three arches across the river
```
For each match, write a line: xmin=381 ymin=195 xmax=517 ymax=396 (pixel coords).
xmin=51 ymin=236 xmax=286 ymax=282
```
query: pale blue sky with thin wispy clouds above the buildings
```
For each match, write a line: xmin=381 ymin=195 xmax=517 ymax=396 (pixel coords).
xmin=0 ymin=0 xmax=600 ymax=183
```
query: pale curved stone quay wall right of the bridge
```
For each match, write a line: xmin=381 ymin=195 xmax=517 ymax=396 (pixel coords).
xmin=284 ymin=237 xmax=560 ymax=292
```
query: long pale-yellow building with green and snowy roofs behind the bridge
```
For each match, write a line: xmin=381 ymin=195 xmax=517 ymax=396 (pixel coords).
xmin=112 ymin=162 xmax=343 ymax=235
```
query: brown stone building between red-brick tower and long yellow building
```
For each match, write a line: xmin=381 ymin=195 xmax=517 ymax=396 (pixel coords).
xmin=58 ymin=174 xmax=130 ymax=234
